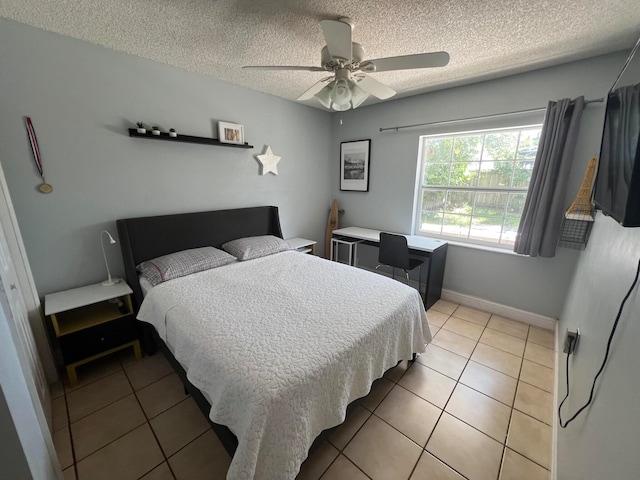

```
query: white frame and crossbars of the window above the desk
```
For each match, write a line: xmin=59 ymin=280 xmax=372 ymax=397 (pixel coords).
xmin=413 ymin=122 xmax=542 ymax=251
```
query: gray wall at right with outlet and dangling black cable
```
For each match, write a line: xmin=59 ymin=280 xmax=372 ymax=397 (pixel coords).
xmin=556 ymin=214 xmax=640 ymax=480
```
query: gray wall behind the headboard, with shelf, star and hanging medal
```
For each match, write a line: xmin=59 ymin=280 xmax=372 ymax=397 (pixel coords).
xmin=0 ymin=19 xmax=331 ymax=296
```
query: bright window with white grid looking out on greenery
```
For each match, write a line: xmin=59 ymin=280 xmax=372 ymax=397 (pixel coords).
xmin=415 ymin=125 xmax=542 ymax=248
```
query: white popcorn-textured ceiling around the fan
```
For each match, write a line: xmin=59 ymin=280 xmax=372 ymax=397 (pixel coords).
xmin=0 ymin=0 xmax=640 ymax=108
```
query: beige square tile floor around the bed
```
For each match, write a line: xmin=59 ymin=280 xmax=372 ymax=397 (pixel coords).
xmin=52 ymin=300 xmax=555 ymax=480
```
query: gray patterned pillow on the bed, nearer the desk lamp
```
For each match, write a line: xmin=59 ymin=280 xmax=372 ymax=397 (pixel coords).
xmin=136 ymin=247 xmax=236 ymax=286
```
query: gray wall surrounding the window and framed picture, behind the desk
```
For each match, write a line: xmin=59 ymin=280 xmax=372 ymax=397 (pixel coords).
xmin=331 ymin=54 xmax=626 ymax=318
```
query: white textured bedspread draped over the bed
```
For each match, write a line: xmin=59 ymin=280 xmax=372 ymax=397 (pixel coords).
xmin=138 ymin=252 xmax=431 ymax=480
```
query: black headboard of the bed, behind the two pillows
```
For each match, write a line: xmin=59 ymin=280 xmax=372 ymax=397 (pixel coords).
xmin=116 ymin=206 xmax=282 ymax=310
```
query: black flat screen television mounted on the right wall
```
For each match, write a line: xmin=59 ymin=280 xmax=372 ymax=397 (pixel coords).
xmin=594 ymin=83 xmax=640 ymax=227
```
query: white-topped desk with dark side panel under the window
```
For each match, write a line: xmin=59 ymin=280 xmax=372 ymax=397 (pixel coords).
xmin=331 ymin=227 xmax=448 ymax=310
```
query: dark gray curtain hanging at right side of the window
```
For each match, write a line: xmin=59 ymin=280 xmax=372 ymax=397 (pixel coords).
xmin=513 ymin=97 xmax=584 ymax=257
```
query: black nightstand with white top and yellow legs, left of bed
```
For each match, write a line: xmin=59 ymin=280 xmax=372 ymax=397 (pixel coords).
xmin=44 ymin=281 xmax=141 ymax=387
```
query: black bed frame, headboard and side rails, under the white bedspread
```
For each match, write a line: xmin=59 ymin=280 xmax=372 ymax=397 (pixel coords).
xmin=116 ymin=206 xmax=380 ymax=456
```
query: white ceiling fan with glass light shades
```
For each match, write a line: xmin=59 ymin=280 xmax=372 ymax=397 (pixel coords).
xmin=242 ymin=17 xmax=449 ymax=111
